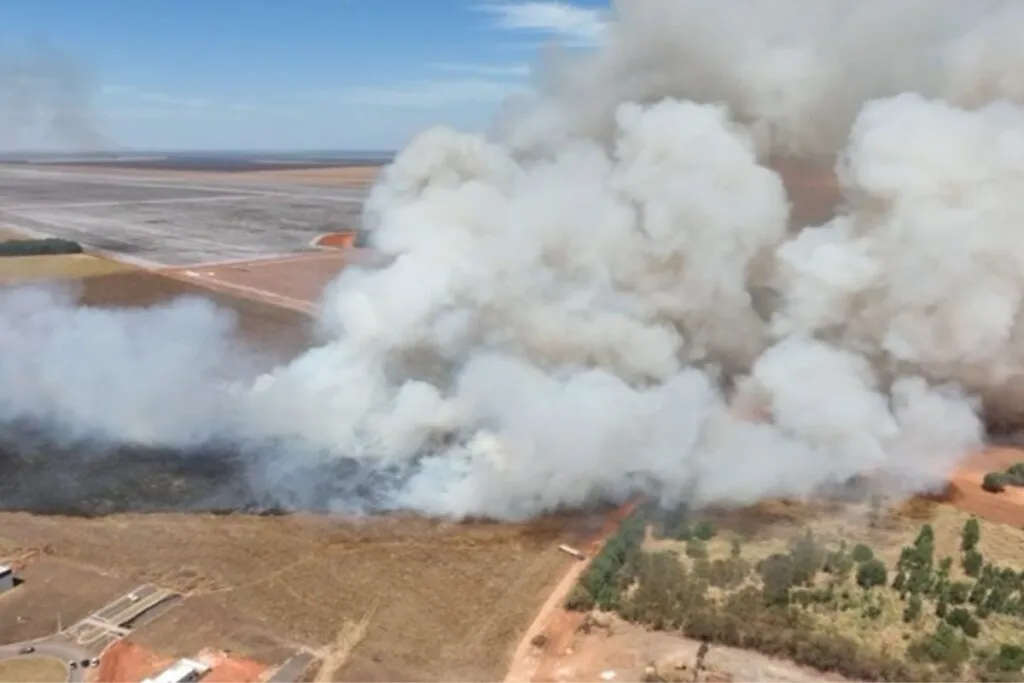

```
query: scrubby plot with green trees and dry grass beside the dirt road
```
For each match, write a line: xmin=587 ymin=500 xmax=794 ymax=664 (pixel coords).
xmin=566 ymin=499 xmax=1024 ymax=681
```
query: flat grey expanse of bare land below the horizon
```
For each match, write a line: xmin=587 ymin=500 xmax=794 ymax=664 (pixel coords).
xmin=0 ymin=166 xmax=366 ymax=266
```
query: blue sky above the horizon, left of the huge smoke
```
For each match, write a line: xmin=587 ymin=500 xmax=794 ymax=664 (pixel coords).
xmin=0 ymin=0 xmax=608 ymax=150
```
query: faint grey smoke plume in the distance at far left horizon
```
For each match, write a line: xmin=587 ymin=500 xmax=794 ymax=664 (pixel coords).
xmin=0 ymin=43 xmax=106 ymax=151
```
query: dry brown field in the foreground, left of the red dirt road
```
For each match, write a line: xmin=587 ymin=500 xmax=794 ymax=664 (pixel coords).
xmin=0 ymin=513 xmax=574 ymax=680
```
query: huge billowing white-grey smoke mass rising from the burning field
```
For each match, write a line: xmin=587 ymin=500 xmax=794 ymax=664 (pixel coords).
xmin=0 ymin=0 xmax=1024 ymax=519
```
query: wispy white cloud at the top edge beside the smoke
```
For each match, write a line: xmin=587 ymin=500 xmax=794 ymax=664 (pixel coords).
xmin=475 ymin=1 xmax=607 ymax=45
